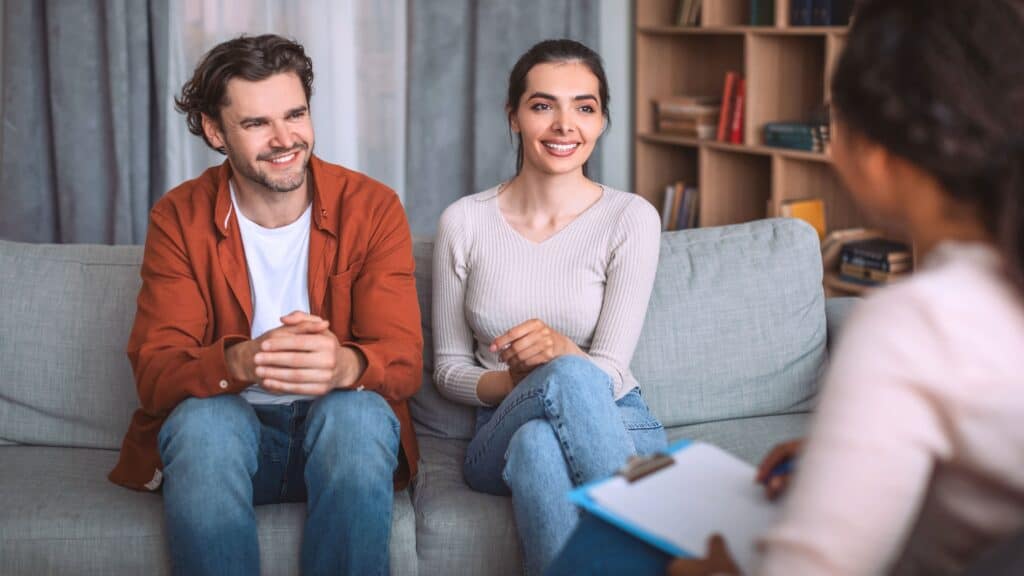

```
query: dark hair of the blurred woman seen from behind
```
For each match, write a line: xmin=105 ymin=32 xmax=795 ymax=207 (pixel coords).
xmin=833 ymin=0 xmax=1024 ymax=289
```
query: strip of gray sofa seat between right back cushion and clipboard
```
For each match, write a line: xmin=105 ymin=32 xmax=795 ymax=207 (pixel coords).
xmin=666 ymin=413 xmax=811 ymax=465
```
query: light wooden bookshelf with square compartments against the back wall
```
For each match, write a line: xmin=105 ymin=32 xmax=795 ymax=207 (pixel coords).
xmin=633 ymin=0 xmax=868 ymax=291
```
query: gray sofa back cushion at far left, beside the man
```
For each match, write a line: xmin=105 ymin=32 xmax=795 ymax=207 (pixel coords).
xmin=0 ymin=241 xmax=142 ymax=449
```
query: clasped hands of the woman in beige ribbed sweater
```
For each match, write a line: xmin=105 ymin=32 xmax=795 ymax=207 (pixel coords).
xmin=490 ymin=319 xmax=585 ymax=375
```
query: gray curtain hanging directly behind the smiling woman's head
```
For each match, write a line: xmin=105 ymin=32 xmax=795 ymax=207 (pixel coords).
xmin=406 ymin=0 xmax=598 ymax=235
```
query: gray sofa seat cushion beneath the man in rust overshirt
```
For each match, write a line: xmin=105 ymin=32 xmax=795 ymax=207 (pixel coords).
xmin=0 ymin=446 xmax=417 ymax=576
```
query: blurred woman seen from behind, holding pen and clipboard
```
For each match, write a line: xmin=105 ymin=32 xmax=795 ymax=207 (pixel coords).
xmin=552 ymin=0 xmax=1024 ymax=575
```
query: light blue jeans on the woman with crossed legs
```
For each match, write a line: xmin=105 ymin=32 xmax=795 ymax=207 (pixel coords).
xmin=463 ymin=356 xmax=667 ymax=574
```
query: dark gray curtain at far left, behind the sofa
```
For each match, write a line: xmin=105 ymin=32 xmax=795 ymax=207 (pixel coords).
xmin=0 ymin=0 xmax=168 ymax=244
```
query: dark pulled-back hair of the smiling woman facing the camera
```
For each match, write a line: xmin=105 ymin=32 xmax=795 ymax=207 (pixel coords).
xmin=505 ymin=38 xmax=611 ymax=174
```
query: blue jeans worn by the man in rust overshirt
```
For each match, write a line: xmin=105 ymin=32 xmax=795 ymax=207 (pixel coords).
xmin=160 ymin=390 xmax=399 ymax=575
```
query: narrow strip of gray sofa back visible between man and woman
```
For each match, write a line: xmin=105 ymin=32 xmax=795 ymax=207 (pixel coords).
xmin=409 ymin=238 xmax=476 ymax=440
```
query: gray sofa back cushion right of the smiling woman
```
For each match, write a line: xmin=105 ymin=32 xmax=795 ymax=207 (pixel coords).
xmin=632 ymin=218 xmax=825 ymax=426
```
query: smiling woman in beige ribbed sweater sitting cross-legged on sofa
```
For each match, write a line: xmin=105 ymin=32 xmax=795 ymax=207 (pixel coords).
xmin=433 ymin=40 xmax=666 ymax=573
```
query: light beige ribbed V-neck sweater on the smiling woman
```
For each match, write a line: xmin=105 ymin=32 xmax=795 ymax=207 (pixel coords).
xmin=433 ymin=187 xmax=660 ymax=406
